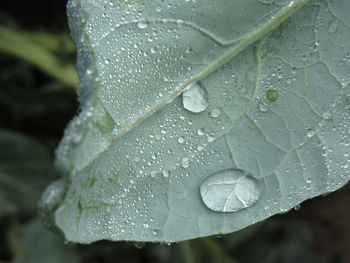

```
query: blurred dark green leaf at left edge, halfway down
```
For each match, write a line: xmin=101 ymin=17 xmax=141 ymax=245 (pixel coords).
xmin=0 ymin=130 xmax=57 ymax=217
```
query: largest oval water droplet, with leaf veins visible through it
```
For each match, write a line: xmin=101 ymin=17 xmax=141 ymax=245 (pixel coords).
xmin=200 ymin=169 xmax=261 ymax=212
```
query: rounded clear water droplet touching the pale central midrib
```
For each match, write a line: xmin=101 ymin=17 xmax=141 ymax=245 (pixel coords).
xmin=182 ymin=82 xmax=208 ymax=113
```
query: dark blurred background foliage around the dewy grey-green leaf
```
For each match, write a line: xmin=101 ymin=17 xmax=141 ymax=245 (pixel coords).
xmin=0 ymin=0 xmax=350 ymax=263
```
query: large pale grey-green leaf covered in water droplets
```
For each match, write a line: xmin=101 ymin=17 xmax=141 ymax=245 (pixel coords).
xmin=47 ymin=0 xmax=350 ymax=243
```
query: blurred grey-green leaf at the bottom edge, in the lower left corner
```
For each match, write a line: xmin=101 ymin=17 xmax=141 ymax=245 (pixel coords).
xmin=13 ymin=219 xmax=79 ymax=263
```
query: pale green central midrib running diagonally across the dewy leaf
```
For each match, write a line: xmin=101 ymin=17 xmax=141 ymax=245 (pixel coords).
xmin=73 ymin=0 xmax=310 ymax=174
